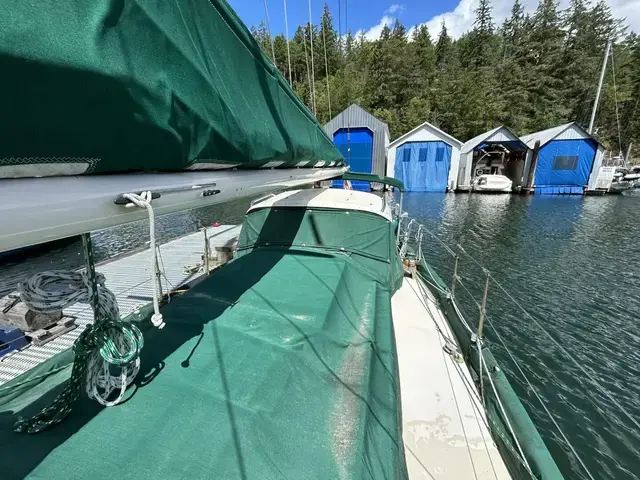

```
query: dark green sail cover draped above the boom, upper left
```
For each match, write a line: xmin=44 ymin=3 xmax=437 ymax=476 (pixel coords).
xmin=0 ymin=0 xmax=343 ymax=177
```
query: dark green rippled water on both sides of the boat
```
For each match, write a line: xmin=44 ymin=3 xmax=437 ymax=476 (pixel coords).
xmin=0 ymin=193 xmax=640 ymax=479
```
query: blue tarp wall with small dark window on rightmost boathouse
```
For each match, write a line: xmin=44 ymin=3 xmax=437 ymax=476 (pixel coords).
xmin=534 ymin=139 xmax=597 ymax=195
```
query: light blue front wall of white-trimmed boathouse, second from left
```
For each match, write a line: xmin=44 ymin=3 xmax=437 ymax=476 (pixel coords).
xmin=395 ymin=142 xmax=451 ymax=192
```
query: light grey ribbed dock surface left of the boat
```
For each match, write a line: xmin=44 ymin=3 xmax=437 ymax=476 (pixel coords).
xmin=0 ymin=225 xmax=240 ymax=385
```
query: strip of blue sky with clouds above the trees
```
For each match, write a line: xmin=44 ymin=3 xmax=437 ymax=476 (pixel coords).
xmin=229 ymin=0 xmax=640 ymax=39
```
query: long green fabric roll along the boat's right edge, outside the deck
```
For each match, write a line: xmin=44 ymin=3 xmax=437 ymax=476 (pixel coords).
xmin=418 ymin=260 xmax=563 ymax=480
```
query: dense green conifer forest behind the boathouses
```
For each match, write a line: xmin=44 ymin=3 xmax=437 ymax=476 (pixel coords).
xmin=251 ymin=0 xmax=640 ymax=152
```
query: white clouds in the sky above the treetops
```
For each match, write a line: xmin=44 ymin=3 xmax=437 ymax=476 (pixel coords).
xmin=358 ymin=0 xmax=640 ymax=40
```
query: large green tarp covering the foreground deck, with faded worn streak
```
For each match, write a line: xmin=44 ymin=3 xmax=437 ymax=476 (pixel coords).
xmin=0 ymin=247 xmax=406 ymax=480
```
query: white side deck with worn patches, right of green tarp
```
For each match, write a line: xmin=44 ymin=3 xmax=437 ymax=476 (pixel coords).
xmin=391 ymin=278 xmax=510 ymax=480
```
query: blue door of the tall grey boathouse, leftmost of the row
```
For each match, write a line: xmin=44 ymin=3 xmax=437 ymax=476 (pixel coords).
xmin=333 ymin=128 xmax=373 ymax=192
